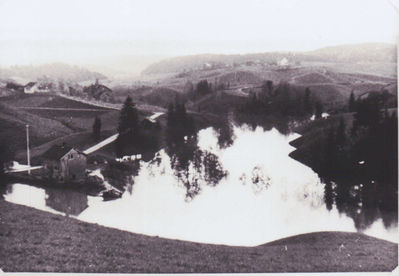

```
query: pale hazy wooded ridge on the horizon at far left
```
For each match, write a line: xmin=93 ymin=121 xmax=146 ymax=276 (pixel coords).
xmin=0 ymin=63 xmax=106 ymax=84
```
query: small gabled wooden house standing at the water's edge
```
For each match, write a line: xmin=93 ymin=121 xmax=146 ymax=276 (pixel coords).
xmin=42 ymin=144 xmax=87 ymax=182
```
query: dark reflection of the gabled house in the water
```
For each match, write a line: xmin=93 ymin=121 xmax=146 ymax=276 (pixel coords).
xmin=46 ymin=189 xmax=88 ymax=216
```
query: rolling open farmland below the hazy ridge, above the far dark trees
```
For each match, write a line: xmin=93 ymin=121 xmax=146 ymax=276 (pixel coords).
xmin=137 ymin=64 xmax=397 ymax=111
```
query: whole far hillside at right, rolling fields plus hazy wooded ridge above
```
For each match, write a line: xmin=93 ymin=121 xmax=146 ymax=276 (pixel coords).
xmin=137 ymin=43 xmax=397 ymax=110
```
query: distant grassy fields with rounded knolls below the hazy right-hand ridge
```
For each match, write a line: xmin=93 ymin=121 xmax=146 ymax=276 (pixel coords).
xmin=145 ymin=65 xmax=396 ymax=107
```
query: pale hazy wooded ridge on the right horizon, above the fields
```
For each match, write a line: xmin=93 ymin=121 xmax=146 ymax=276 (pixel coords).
xmin=142 ymin=43 xmax=397 ymax=75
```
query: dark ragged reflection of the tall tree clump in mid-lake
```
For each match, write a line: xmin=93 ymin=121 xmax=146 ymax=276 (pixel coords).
xmin=166 ymin=130 xmax=227 ymax=199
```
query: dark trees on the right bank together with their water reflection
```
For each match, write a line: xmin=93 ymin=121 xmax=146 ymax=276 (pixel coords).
xmin=313 ymin=95 xmax=398 ymax=218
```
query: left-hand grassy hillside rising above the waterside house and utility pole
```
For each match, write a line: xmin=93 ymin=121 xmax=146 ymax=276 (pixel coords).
xmin=0 ymin=94 xmax=119 ymax=159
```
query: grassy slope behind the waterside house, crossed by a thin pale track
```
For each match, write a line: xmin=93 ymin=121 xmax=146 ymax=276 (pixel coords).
xmin=0 ymin=94 xmax=119 ymax=162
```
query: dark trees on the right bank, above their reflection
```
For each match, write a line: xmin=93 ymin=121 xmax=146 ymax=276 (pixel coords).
xmin=319 ymin=90 xmax=398 ymax=183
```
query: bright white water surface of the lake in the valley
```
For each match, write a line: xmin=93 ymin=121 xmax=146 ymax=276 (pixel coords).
xmin=3 ymin=126 xmax=397 ymax=246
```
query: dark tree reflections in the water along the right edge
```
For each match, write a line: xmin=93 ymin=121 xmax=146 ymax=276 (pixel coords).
xmin=324 ymin=180 xmax=398 ymax=230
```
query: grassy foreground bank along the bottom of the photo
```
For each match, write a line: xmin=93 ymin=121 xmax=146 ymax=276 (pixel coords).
xmin=0 ymin=200 xmax=398 ymax=273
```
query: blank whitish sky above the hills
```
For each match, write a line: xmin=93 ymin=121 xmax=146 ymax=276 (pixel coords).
xmin=0 ymin=0 xmax=399 ymax=66
